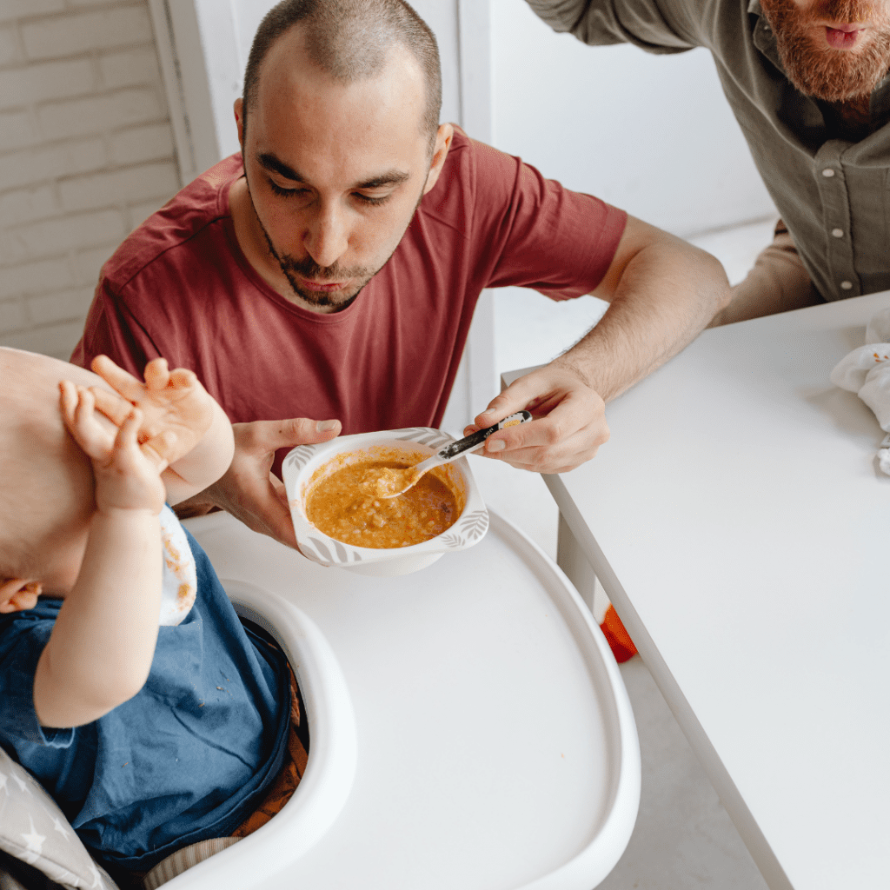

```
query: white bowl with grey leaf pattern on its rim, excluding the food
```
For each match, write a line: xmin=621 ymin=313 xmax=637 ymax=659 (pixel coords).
xmin=282 ymin=427 xmax=488 ymax=576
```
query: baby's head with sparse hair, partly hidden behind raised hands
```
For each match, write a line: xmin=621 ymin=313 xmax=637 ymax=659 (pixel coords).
xmin=0 ymin=348 xmax=107 ymax=612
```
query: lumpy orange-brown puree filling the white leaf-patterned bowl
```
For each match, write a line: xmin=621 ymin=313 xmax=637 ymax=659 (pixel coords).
xmin=305 ymin=456 xmax=462 ymax=549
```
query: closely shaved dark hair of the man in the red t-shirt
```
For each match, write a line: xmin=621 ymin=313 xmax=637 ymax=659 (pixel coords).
xmin=242 ymin=0 xmax=442 ymax=145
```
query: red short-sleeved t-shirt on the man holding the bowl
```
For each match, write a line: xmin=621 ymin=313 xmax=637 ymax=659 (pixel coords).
xmin=72 ymin=128 xmax=626 ymax=442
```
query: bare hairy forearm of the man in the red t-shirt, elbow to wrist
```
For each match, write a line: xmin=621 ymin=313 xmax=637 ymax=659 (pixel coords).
xmin=553 ymin=236 xmax=729 ymax=402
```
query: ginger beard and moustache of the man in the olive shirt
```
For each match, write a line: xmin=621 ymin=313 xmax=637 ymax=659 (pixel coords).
xmin=761 ymin=0 xmax=890 ymax=102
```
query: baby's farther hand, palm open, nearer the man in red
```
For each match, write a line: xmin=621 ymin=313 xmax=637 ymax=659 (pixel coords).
xmin=91 ymin=355 xmax=213 ymax=464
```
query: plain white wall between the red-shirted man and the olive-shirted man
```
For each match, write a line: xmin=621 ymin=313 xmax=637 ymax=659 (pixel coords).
xmin=491 ymin=0 xmax=773 ymax=236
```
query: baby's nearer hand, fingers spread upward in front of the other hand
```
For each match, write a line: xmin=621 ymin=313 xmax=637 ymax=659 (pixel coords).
xmin=59 ymin=380 xmax=175 ymax=513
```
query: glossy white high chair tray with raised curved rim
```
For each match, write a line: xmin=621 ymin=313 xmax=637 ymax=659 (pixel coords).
xmin=179 ymin=513 xmax=640 ymax=890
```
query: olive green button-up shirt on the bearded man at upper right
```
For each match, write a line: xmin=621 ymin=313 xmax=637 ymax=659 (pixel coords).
xmin=527 ymin=0 xmax=890 ymax=300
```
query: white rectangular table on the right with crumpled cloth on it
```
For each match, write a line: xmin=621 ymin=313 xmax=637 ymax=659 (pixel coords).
xmin=505 ymin=293 xmax=890 ymax=890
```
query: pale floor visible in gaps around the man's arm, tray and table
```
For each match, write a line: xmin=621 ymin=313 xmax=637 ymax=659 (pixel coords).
xmin=471 ymin=220 xmax=774 ymax=890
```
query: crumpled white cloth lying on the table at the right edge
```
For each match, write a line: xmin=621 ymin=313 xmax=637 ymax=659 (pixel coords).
xmin=831 ymin=307 xmax=890 ymax=476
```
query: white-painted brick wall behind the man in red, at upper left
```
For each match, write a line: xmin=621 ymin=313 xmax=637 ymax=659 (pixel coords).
xmin=0 ymin=0 xmax=179 ymax=359
